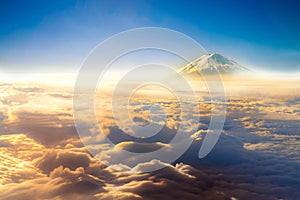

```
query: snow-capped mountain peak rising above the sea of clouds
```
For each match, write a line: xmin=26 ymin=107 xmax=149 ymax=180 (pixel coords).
xmin=179 ymin=53 xmax=250 ymax=74
